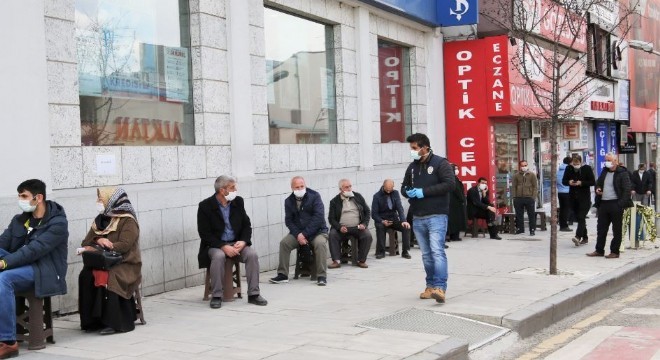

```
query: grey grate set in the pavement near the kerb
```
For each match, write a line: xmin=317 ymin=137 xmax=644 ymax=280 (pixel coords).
xmin=357 ymin=309 xmax=509 ymax=350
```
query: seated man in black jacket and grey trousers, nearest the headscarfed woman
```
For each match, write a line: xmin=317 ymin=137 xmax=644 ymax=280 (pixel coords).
xmin=197 ymin=175 xmax=268 ymax=309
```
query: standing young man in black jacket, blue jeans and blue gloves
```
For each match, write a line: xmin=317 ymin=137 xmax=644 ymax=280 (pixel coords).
xmin=401 ymin=133 xmax=455 ymax=303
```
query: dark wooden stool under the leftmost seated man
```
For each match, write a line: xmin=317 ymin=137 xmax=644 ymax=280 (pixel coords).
xmin=15 ymin=292 xmax=55 ymax=350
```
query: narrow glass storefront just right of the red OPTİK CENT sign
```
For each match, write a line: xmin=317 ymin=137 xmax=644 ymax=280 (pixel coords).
xmin=494 ymin=124 xmax=518 ymax=214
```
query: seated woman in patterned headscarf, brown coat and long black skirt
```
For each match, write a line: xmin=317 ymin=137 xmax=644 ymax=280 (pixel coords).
xmin=78 ymin=188 xmax=142 ymax=335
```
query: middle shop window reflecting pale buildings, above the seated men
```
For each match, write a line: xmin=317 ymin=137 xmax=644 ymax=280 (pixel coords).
xmin=264 ymin=8 xmax=337 ymax=144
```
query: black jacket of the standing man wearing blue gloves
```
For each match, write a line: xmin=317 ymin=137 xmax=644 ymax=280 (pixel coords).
xmin=401 ymin=153 xmax=456 ymax=216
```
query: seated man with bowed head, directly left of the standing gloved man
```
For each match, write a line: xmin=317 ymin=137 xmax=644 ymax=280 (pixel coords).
xmin=371 ymin=179 xmax=410 ymax=259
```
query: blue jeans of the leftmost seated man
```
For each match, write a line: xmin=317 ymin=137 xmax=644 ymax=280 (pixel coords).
xmin=0 ymin=249 xmax=34 ymax=341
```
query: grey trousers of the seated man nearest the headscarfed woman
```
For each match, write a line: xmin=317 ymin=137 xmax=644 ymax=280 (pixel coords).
xmin=209 ymin=246 xmax=259 ymax=298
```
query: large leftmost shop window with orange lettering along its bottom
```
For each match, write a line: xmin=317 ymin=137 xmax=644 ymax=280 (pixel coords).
xmin=75 ymin=0 xmax=194 ymax=146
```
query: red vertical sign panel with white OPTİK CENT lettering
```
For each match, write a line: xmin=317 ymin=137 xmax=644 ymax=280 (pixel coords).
xmin=444 ymin=40 xmax=492 ymax=188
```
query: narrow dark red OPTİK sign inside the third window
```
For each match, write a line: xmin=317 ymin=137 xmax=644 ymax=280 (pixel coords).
xmin=378 ymin=46 xmax=406 ymax=143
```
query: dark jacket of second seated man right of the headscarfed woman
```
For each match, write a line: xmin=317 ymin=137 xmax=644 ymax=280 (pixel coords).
xmin=284 ymin=188 xmax=328 ymax=241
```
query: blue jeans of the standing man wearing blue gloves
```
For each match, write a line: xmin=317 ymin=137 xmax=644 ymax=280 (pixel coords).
xmin=413 ymin=215 xmax=448 ymax=291
